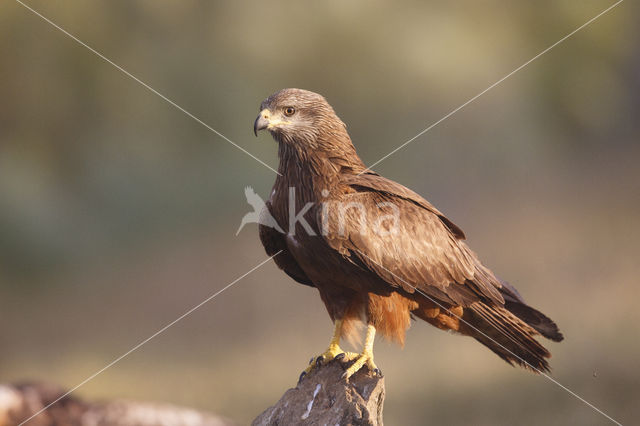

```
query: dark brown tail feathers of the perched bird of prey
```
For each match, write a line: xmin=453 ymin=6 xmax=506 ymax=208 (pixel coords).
xmin=460 ymin=302 xmax=562 ymax=373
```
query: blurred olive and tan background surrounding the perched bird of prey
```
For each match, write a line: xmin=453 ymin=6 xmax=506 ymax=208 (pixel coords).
xmin=0 ymin=0 xmax=640 ymax=425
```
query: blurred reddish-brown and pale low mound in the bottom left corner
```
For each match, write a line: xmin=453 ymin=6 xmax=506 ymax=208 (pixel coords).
xmin=0 ymin=383 xmax=233 ymax=426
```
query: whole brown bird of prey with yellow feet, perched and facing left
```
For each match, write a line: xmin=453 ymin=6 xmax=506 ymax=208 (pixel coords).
xmin=254 ymin=89 xmax=563 ymax=379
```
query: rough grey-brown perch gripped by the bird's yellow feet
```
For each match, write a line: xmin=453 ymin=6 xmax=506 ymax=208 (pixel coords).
xmin=253 ymin=360 xmax=384 ymax=426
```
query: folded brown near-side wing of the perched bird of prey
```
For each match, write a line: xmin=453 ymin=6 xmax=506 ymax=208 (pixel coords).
xmin=323 ymin=175 xmax=504 ymax=306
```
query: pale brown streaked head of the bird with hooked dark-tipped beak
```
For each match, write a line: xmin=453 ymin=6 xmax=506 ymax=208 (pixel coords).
xmin=253 ymin=89 xmax=348 ymax=148
